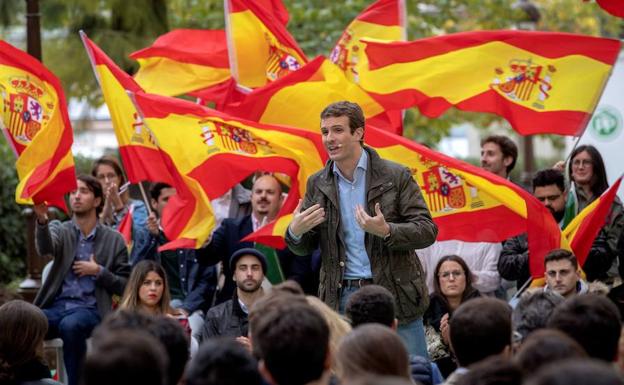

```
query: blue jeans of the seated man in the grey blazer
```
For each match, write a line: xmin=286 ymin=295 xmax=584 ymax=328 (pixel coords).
xmin=42 ymin=306 xmax=100 ymax=385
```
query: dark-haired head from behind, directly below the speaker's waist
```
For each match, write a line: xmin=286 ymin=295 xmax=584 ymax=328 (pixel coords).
xmin=345 ymin=285 xmax=397 ymax=328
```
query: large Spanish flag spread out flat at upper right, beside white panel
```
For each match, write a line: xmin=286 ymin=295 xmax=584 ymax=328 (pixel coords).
xmin=358 ymin=31 xmax=620 ymax=135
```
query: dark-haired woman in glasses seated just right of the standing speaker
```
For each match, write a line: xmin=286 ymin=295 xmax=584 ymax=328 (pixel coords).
xmin=424 ymin=255 xmax=481 ymax=377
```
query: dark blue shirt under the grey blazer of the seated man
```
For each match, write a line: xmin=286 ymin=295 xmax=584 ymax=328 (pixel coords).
xmin=54 ymin=223 xmax=97 ymax=310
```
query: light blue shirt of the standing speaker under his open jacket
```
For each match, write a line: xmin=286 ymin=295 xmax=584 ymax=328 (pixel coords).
xmin=333 ymin=151 xmax=373 ymax=279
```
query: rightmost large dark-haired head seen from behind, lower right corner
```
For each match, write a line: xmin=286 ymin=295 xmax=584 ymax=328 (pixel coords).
xmin=548 ymin=294 xmax=621 ymax=362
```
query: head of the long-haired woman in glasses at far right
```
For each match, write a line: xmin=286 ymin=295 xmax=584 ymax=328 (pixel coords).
xmin=568 ymin=144 xmax=609 ymax=197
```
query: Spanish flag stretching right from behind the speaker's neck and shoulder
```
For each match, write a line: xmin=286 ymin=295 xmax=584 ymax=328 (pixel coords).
xmin=364 ymin=127 xmax=561 ymax=275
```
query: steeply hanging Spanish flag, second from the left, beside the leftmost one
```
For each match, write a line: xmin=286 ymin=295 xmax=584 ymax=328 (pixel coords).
xmin=81 ymin=33 xmax=172 ymax=183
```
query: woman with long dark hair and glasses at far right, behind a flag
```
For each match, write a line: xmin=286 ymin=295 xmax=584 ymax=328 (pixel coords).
xmin=563 ymin=145 xmax=624 ymax=283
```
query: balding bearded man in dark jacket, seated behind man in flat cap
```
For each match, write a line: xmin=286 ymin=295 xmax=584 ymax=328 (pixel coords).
xmin=197 ymin=175 xmax=318 ymax=304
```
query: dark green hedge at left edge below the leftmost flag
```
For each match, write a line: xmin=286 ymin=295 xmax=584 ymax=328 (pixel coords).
xmin=0 ymin=140 xmax=26 ymax=285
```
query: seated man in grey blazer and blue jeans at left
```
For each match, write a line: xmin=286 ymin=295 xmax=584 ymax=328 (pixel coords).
xmin=34 ymin=175 xmax=130 ymax=385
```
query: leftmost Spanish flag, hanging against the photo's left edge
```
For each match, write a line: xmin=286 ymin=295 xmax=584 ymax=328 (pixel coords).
xmin=0 ymin=40 xmax=76 ymax=211
